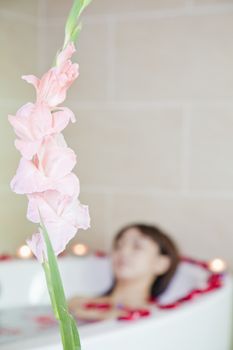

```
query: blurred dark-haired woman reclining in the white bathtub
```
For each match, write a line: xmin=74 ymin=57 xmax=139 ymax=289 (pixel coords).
xmin=69 ymin=223 xmax=179 ymax=320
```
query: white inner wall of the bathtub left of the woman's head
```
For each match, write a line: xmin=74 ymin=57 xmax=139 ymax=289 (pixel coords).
xmin=0 ymin=255 xmax=112 ymax=309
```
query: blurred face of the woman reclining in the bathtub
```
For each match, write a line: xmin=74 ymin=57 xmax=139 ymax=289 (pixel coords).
xmin=112 ymin=228 xmax=168 ymax=279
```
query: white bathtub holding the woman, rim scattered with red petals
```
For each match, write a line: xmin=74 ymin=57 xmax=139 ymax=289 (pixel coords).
xmin=0 ymin=256 xmax=233 ymax=350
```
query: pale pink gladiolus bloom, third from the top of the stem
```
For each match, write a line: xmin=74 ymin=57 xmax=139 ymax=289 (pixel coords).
xmin=11 ymin=134 xmax=79 ymax=197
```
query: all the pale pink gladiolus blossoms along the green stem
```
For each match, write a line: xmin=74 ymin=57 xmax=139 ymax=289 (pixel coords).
xmin=8 ymin=43 xmax=90 ymax=262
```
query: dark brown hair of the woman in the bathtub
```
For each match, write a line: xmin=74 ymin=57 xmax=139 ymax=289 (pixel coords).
xmin=102 ymin=223 xmax=180 ymax=299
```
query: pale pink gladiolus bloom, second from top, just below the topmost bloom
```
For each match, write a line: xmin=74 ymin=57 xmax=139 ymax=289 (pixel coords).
xmin=8 ymin=103 xmax=75 ymax=159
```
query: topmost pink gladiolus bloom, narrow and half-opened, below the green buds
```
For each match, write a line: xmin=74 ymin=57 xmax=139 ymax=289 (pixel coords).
xmin=22 ymin=43 xmax=79 ymax=107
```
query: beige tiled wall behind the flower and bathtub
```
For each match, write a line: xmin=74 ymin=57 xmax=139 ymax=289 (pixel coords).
xmin=0 ymin=0 xmax=233 ymax=265
